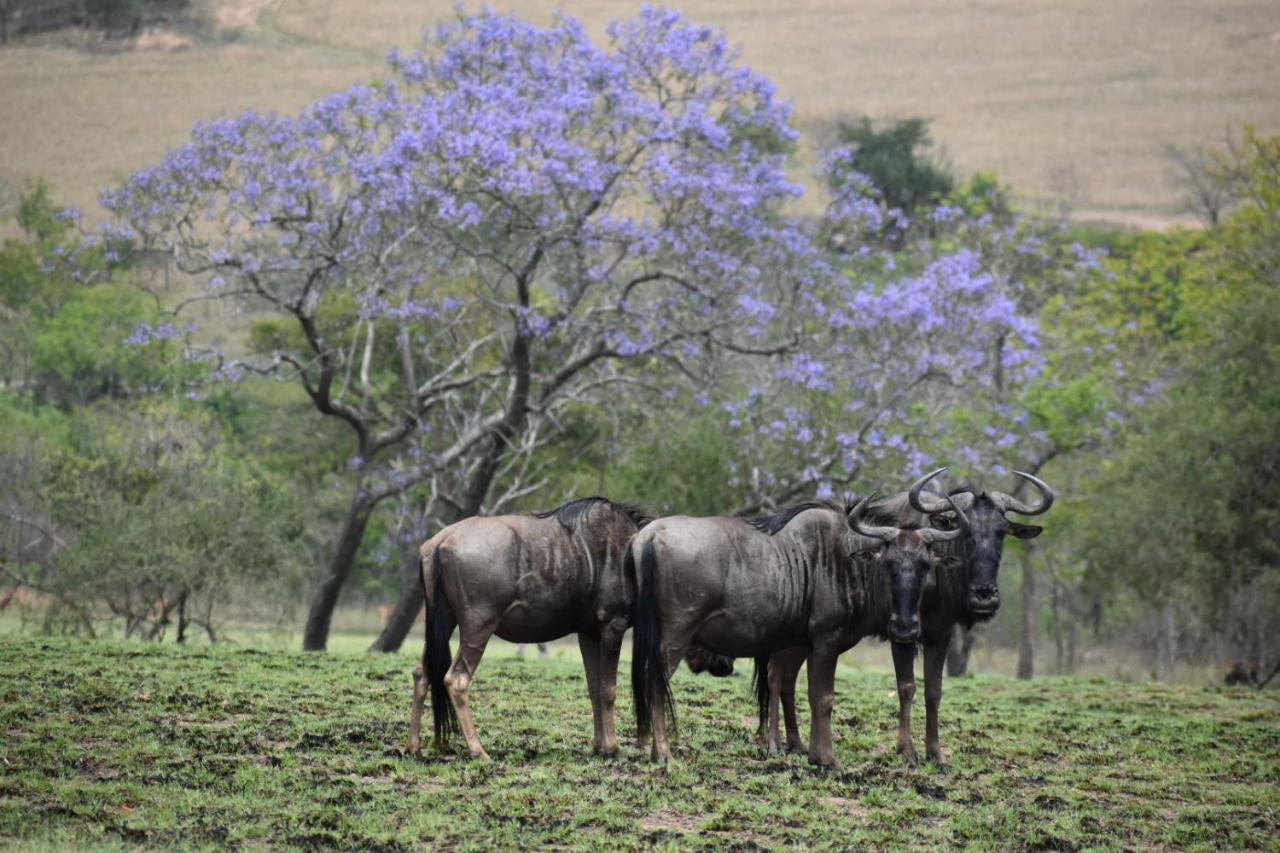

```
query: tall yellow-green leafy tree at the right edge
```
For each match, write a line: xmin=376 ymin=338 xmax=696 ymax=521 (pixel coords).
xmin=1084 ymin=133 xmax=1280 ymax=637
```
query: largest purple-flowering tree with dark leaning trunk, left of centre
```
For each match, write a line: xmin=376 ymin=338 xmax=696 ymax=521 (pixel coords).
xmin=104 ymin=9 xmax=812 ymax=649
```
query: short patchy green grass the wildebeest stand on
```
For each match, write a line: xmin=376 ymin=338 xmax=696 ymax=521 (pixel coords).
xmin=0 ymin=635 xmax=1280 ymax=849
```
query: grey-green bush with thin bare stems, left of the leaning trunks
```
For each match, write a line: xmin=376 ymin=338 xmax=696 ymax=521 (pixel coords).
xmin=9 ymin=401 xmax=307 ymax=639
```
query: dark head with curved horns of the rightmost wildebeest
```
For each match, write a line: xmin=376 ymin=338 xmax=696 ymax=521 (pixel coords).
xmin=908 ymin=467 xmax=1053 ymax=617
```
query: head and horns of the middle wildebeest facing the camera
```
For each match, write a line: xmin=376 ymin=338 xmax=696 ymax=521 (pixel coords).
xmin=849 ymin=496 xmax=963 ymax=643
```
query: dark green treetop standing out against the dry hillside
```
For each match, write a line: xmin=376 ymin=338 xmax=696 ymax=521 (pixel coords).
xmin=836 ymin=117 xmax=955 ymax=216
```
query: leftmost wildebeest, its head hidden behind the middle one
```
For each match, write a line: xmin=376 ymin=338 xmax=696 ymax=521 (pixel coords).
xmin=410 ymin=497 xmax=733 ymax=760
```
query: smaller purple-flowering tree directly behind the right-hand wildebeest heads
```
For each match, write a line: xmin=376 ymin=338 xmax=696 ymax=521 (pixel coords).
xmin=700 ymin=150 xmax=1100 ymax=508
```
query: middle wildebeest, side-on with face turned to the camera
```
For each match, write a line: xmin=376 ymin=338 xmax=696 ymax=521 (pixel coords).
xmin=626 ymin=491 xmax=960 ymax=766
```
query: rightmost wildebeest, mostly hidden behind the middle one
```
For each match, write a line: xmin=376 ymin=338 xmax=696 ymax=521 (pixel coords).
xmin=755 ymin=467 xmax=1053 ymax=763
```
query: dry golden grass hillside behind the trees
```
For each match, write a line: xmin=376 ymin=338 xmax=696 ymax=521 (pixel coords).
xmin=0 ymin=0 xmax=1280 ymax=224
